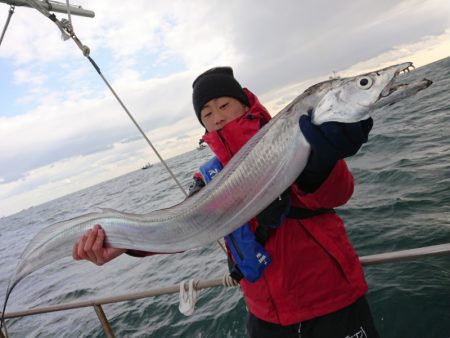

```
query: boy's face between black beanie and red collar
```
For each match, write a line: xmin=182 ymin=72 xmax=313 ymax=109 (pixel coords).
xmin=200 ymin=96 xmax=249 ymax=132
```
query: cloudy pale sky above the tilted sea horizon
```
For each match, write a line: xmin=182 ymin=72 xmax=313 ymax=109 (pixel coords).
xmin=0 ymin=0 xmax=450 ymax=217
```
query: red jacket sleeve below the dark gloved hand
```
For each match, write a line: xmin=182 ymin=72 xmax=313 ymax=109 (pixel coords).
xmin=300 ymin=160 xmax=354 ymax=209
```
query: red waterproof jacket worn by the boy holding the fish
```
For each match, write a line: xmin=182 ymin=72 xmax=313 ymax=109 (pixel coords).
xmin=203 ymin=90 xmax=367 ymax=325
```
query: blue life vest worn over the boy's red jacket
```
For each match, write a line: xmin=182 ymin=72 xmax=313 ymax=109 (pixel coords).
xmin=200 ymin=156 xmax=271 ymax=282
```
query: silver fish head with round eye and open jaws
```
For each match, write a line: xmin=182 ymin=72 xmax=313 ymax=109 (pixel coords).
xmin=310 ymin=62 xmax=432 ymax=125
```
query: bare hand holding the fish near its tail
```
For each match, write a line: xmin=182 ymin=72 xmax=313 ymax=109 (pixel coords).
xmin=72 ymin=224 xmax=125 ymax=265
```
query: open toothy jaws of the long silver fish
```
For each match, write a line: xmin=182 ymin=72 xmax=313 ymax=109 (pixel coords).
xmin=377 ymin=62 xmax=433 ymax=105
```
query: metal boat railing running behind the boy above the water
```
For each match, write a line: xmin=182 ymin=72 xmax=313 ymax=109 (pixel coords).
xmin=0 ymin=243 xmax=450 ymax=338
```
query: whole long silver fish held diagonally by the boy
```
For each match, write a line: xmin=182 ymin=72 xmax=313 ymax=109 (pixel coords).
xmin=7 ymin=62 xmax=431 ymax=298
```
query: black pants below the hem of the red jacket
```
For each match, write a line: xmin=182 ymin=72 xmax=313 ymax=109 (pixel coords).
xmin=247 ymin=297 xmax=379 ymax=338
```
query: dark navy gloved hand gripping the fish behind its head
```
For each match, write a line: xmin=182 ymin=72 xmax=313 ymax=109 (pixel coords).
xmin=299 ymin=115 xmax=373 ymax=173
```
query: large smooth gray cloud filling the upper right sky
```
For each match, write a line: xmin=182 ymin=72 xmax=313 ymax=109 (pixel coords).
xmin=229 ymin=1 xmax=450 ymax=92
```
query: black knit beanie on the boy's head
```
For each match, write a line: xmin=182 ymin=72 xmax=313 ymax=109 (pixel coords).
xmin=192 ymin=67 xmax=250 ymax=124
